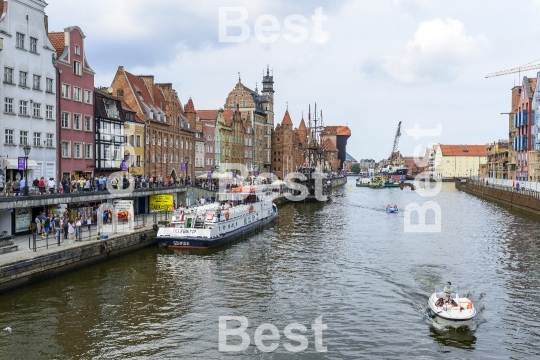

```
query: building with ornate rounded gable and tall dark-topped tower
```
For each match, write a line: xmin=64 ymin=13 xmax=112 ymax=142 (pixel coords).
xmin=225 ymin=67 xmax=274 ymax=172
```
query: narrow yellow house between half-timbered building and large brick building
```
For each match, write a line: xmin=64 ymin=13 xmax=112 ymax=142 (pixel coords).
xmin=122 ymin=101 xmax=145 ymax=176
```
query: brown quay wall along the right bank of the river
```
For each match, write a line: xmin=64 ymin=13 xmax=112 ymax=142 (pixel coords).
xmin=456 ymin=181 xmax=540 ymax=215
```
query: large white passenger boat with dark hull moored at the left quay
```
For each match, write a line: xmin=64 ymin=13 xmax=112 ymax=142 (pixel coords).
xmin=157 ymin=196 xmax=278 ymax=249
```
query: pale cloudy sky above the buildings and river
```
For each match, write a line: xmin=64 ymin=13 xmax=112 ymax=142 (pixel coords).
xmin=46 ymin=0 xmax=540 ymax=161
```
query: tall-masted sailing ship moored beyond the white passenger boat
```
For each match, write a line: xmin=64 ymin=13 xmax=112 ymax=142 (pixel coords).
xmin=293 ymin=103 xmax=332 ymax=203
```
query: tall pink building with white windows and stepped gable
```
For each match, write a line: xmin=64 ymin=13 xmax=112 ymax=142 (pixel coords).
xmin=49 ymin=26 xmax=94 ymax=180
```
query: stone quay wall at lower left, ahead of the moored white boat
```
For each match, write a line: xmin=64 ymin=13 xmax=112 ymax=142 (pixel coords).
xmin=0 ymin=229 xmax=157 ymax=292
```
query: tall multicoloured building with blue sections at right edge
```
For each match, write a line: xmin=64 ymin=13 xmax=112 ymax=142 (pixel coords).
xmin=513 ymin=76 xmax=536 ymax=180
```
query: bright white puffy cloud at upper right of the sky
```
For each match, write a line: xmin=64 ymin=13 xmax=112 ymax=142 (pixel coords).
xmin=362 ymin=18 xmax=487 ymax=83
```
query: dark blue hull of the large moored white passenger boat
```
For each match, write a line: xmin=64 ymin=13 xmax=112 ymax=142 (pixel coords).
xmin=157 ymin=211 xmax=277 ymax=250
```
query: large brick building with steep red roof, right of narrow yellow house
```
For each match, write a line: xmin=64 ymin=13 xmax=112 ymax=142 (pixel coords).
xmin=111 ymin=66 xmax=195 ymax=179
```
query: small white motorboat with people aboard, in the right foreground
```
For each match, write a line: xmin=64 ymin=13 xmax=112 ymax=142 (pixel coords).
xmin=428 ymin=284 xmax=476 ymax=328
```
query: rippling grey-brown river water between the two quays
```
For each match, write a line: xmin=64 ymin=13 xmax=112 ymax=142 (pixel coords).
xmin=0 ymin=178 xmax=540 ymax=359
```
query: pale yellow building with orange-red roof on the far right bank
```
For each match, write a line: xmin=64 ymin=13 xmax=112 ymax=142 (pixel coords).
xmin=434 ymin=144 xmax=487 ymax=178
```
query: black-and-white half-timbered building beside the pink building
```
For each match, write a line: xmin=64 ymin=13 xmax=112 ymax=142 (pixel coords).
xmin=94 ymin=88 xmax=127 ymax=176
